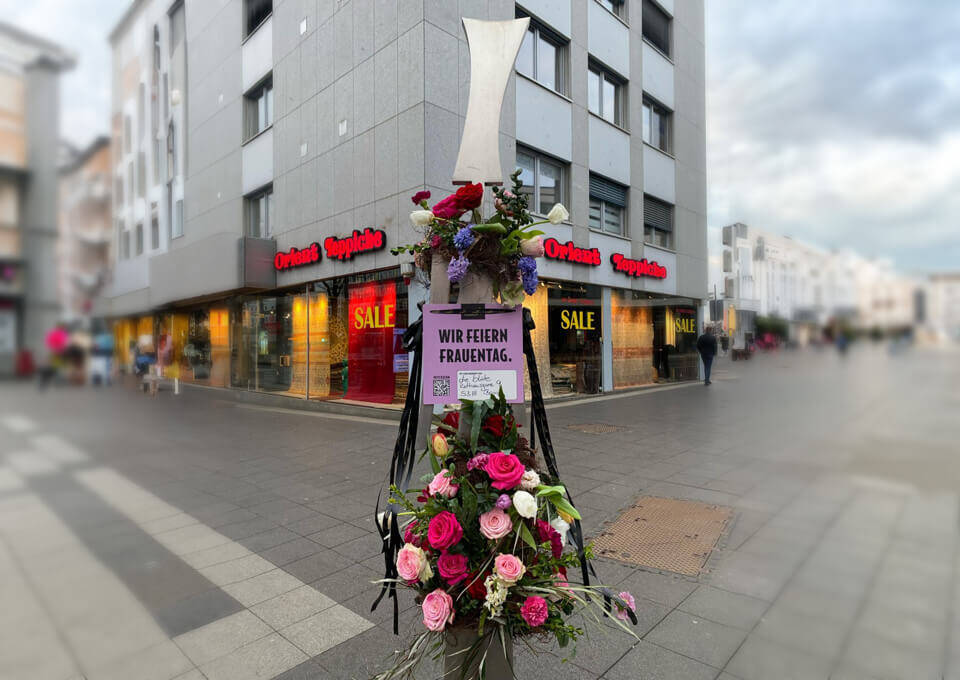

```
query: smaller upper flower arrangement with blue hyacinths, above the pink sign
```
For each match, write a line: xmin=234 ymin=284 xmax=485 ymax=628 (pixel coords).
xmin=391 ymin=170 xmax=570 ymax=305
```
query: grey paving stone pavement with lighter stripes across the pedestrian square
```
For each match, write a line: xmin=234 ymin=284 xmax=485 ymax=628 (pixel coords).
xmin=0 ymin=346 xmax=960 ymax=680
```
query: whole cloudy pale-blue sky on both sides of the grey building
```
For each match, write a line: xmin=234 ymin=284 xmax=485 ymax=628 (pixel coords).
xmin=0 ymin=0 xmax=960 ymax=271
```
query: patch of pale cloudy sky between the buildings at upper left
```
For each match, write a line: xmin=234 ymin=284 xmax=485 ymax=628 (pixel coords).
xmin=0 ymin=0 xmax=132 ymax=147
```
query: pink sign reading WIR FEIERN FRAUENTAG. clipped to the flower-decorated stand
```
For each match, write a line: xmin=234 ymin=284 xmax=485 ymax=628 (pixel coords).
xmin=423 ymin=305 xmax=523 ymax=404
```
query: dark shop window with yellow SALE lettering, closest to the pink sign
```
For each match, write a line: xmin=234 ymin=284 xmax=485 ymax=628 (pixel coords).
xmin=547 ymin=282 xmax=602 ymax=394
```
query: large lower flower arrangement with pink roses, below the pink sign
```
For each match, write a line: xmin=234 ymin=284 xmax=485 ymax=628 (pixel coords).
xmin=377 ymin=391 xmax=635 ymax=680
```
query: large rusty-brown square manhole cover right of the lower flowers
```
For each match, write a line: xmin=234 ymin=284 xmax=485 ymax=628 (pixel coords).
xmin=593 ymin=496 xmax=733 ymax=576
